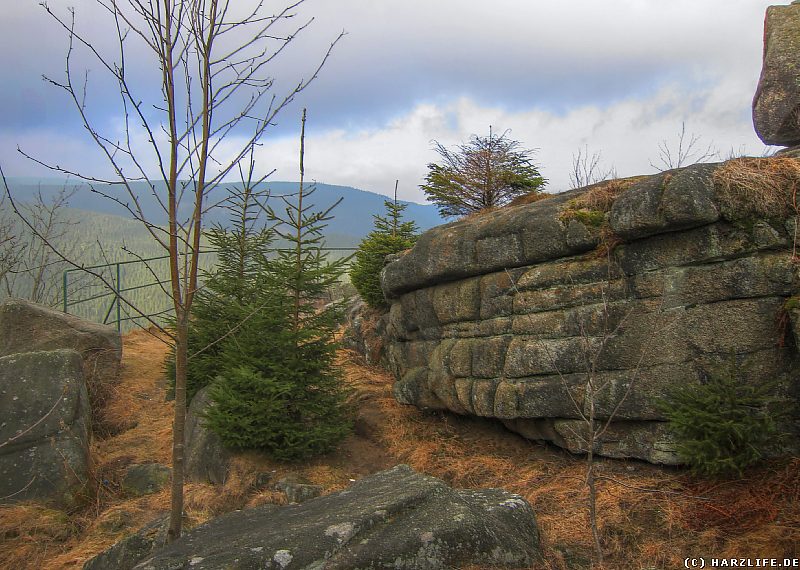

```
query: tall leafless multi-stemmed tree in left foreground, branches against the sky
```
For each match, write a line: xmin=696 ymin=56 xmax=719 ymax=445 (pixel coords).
xmin=9 ymin=0 xmax=342 ymax=541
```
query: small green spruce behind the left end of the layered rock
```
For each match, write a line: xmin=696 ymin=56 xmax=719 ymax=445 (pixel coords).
xmin=350 ymin=194 xmax=418 ymax=311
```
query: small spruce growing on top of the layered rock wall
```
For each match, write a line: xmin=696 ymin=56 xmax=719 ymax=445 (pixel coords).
xmin=420 ymin=127 xmax=547 ymax=217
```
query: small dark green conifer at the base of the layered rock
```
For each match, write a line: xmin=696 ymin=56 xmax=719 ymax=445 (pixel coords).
xmin=661 ymin=364 xmax=786 ymax=476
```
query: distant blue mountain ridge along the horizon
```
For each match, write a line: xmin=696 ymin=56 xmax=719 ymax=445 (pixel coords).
xmin=1 ymin=177 xmax=444 ymax=247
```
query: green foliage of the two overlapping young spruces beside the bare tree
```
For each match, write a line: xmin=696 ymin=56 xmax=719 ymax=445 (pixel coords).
xmin=167 ymin=145 xmax=351 ymax=460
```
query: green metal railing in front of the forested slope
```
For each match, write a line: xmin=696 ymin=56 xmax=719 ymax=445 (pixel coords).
xmin=61 ymin=247 xmax=357 ymax=331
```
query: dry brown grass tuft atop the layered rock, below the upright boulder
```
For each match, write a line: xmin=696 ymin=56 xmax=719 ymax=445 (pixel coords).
xmin=714 ymin=157 xmax=800 ymax=219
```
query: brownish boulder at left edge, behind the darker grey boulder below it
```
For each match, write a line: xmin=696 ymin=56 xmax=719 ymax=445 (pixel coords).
xmin=0 ymin=299 xmax=122 ymax=435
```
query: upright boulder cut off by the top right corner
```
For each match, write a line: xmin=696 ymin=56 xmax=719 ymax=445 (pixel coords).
xmin=753 ymin=2 xmax=800 ymax=146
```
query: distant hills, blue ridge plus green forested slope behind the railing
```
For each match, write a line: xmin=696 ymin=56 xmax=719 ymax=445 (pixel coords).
xmin=0 ymin=178 xmax=442 ymax=329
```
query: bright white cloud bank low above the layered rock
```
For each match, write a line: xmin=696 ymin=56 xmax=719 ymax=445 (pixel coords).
xmin=250 ymin=70 xmax=763 ymax=201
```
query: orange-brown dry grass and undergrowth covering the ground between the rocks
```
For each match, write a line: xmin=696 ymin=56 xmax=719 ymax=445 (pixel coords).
xmin=0 ymin=332 xmax=800 ymax=569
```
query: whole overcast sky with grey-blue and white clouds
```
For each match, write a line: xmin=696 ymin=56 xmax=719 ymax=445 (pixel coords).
xmin=0 ymin=0 xmax=789 ymax=202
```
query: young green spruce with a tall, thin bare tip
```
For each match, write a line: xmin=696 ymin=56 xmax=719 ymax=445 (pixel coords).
xmin=206 ymin=111 xmax=350 ymax=460
